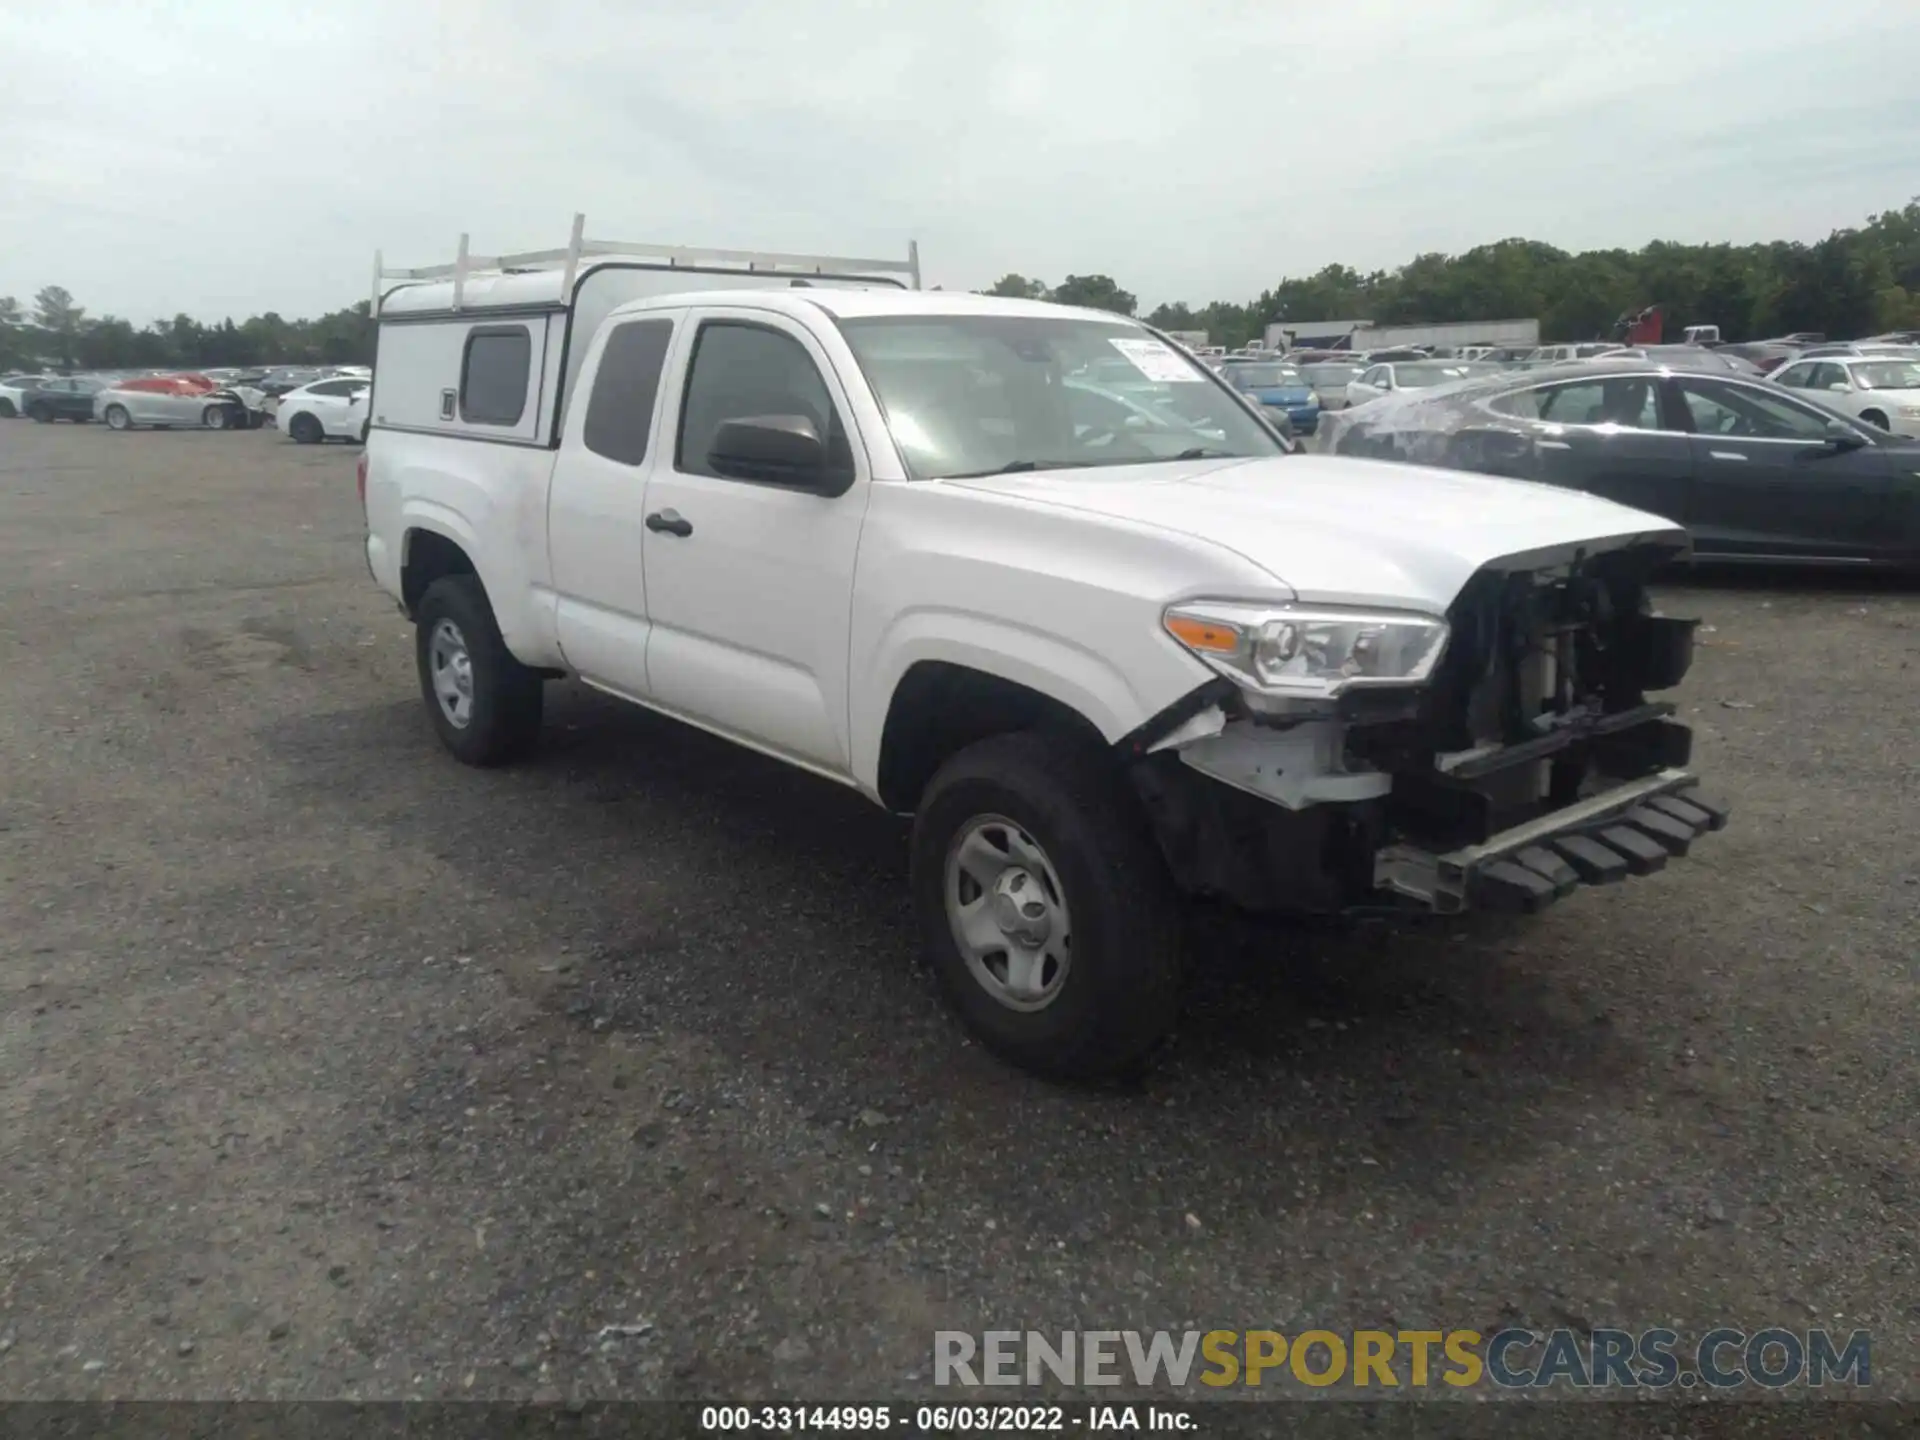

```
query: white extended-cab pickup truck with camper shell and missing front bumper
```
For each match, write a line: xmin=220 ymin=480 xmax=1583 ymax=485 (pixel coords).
xmin=361 ymin=227 xmax=1726 ymax=1075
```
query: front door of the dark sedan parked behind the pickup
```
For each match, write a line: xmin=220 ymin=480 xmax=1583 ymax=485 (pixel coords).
xmin=1674 ymin=374 xmax=1903 ymax=561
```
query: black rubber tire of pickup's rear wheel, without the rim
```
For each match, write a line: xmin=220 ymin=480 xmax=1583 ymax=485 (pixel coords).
xmin=413 ymin=574 xmax=545 ymax=766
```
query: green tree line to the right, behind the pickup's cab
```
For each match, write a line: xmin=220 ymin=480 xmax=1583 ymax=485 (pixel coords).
xmin=983 ymin=198 xmax=1920 ymax=346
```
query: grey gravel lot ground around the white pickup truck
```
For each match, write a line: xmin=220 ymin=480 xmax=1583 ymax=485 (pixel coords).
xmin=0 ymin=422 xmax=1920 ymax=1400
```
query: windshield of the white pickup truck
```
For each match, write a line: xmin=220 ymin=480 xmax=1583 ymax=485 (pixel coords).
xmin=839 ymin=315 xmax=1284 ymax=480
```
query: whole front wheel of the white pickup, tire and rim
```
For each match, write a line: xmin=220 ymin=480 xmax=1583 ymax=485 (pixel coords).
xmin=912 ymin=732 xmax=1181 ymax=1077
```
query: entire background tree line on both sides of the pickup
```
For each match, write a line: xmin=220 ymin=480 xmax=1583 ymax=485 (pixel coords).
xmin=0 ymin=198 xmax=1920 ymax=371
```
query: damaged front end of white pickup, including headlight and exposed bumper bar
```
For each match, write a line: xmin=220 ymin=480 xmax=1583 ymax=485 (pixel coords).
xmin=1121 ymin=540 xmax=1726 ymax=914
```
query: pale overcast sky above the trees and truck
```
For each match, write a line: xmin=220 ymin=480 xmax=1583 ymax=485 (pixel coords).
xmin=11 ymin=0 xmax=1920 ymax=323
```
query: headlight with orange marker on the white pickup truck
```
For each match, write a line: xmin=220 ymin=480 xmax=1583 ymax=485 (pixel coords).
xmin=1162 ymin=601 xmax=1448 ymax=699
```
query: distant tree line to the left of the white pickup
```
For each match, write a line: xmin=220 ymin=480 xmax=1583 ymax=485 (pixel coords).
xmin=0 ymin=284 xmax=374 ymax=371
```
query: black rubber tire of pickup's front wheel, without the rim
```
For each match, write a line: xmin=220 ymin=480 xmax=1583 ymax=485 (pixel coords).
xmin=912 ymin=732 xmax=1183 ymax=1079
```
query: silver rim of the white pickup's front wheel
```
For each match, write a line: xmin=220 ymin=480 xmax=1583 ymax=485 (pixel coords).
xmin=945 ymin=814 xmax=1073 ymax=1012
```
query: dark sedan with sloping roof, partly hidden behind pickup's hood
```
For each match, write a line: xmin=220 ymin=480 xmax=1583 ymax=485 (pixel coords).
xmin=1321 ymin=359 xmax=1920 ymax=566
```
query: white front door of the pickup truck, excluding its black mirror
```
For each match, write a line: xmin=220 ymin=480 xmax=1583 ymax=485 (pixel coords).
xmin=643 ymin=307 xmax=868 ymax=776
